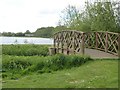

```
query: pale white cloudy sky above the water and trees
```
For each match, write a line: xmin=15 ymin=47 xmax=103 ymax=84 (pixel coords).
xmin=0 ymin=0 xmax=85 ymax=32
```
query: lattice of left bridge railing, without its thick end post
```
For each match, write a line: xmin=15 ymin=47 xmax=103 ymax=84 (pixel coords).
xmin=54 ymin=30 xmax=82 ymax=53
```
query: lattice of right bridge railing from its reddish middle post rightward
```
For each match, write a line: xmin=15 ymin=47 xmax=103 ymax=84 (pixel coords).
xmin=96 ymin=32 xmax=119 ymax=55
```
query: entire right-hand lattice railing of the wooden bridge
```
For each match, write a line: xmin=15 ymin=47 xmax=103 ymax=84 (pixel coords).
xmin=85 ymin=32 xmax=120 ymax=56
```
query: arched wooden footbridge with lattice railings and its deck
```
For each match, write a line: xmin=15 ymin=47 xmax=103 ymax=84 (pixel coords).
xmin=50 ymin=30 xmax=120 ymax=58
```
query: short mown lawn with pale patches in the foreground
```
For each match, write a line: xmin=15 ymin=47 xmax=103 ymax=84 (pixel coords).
xmin=3 ymin=60 xmax=118 ymax=88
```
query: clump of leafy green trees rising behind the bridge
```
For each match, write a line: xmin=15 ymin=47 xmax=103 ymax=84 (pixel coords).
xmin=59 ymin=0 xmax=120 ymax=32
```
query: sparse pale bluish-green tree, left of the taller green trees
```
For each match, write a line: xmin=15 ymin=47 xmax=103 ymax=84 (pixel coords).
xmin=59 ymin=5 xmax=79 ymax=29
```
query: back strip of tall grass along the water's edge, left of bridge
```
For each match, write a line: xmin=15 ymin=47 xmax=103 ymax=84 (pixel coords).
xmin=2 ymin=44 xmax=49 ymax=56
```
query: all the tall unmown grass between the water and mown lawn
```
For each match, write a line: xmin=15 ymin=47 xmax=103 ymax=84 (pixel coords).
xmin=2 ymin=45 xmax=91 ymax=78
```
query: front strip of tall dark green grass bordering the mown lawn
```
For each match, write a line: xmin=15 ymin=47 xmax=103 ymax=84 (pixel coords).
xmin=2 ymin=54 xmax=91 ymax=75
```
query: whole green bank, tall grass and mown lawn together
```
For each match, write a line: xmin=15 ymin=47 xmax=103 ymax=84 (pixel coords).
xmin=2 ymin=45 xmax=118 ymax=88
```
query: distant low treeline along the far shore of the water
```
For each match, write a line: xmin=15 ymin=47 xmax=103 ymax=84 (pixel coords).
xmin=1 ymin=26 xmax=68 ymax=38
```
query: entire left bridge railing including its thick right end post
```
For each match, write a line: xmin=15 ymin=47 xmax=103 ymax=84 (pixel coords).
xmin=51 ymin=30 xmax=84 ymax=54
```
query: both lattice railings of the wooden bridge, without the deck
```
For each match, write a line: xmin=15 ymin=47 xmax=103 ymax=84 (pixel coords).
xmin=54 ymin=30 xmax=120 ymax=57
